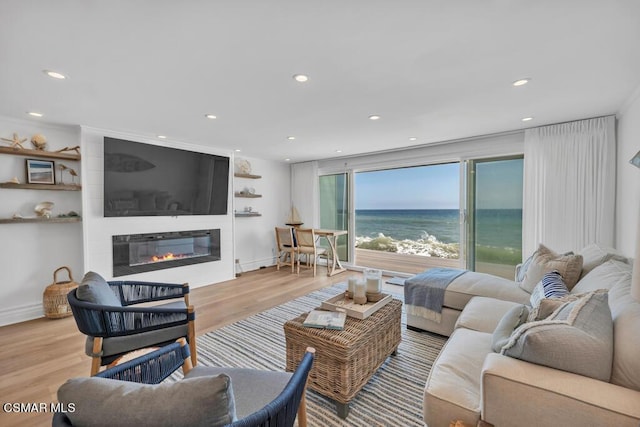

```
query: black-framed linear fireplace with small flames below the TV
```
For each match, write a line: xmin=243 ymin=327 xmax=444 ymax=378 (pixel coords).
xmin=112 ymin=229 xmax=220 ymax=277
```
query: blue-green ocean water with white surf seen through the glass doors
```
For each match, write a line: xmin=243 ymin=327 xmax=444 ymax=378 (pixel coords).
xmin=356 ymin=209 xmax=522 ymax=263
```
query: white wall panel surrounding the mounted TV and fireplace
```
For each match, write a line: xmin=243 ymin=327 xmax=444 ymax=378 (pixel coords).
xmin=81 ymin=127 xmax=234 ymax=288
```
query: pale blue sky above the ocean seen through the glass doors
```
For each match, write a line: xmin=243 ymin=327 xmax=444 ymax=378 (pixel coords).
xmin=355 ymin=159 xmax=522 ymax=209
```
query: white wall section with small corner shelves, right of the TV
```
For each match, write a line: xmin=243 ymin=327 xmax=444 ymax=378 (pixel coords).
xmin=233 ymin=156 xmax=291 ymax=271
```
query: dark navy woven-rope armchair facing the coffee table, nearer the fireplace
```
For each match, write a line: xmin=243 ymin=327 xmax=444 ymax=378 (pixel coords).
xmin=67 ymin=281 xmax=197 ymax=375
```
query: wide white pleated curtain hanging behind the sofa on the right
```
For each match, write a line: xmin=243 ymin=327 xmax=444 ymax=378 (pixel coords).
xmin=522 ymin=116 xmax=616 ymax=258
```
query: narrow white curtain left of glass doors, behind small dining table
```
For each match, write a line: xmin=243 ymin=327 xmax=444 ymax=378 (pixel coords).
xmin=291 ymin=161 xmax=319 ymax=228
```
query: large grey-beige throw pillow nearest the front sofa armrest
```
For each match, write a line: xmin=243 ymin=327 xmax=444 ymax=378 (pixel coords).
xmin=501 ymin=291 xmax=613 ymax=381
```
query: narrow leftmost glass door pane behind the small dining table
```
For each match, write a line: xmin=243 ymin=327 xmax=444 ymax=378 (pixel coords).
xmin=319 ymin=173 xmax=350 ymax=261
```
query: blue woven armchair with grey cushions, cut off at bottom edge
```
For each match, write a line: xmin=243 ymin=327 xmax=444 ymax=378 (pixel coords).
xmin=52 ymin=338 xmax=315 ymax=427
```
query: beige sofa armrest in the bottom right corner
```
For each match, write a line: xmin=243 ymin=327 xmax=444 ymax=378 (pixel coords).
xmin=481 ymin=353 xmax=640 ymax=427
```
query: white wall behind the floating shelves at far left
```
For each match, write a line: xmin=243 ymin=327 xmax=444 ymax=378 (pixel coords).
xmin=0 ymin=117 xmax=83 ymax=325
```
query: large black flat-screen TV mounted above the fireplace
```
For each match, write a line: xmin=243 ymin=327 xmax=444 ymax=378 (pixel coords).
xmin=104 ymin=137 xmax=229 ymax=217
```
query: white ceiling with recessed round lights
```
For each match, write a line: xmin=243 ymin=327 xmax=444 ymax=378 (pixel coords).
xmin=0 ymin=0 xmax=640 ymax=162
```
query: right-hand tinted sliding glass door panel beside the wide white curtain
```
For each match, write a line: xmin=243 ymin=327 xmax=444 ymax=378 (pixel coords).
xmin=466 ymin=156 xmax=523 ymax=279
